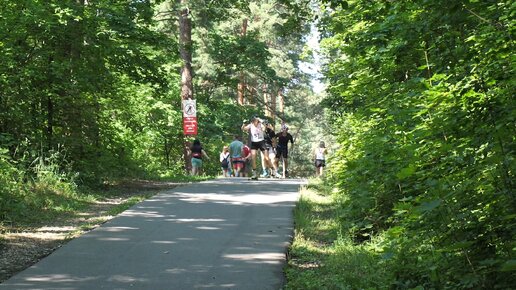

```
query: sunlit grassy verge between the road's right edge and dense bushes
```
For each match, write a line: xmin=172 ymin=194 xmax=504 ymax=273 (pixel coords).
xmin=285 ymin=179 xmax=389 ymax=289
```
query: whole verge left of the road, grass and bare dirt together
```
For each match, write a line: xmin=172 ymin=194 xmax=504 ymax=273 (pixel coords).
xmin=0 ymin=176 xmax=216 ymax=283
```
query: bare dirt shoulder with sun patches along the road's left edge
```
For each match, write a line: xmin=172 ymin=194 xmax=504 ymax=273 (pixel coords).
xmin=0 ymin=181 xmax=181 ymax=283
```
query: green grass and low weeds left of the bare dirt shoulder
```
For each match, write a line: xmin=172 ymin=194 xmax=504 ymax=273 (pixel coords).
xmin=0 ymin=176 xmax=211 ymax=231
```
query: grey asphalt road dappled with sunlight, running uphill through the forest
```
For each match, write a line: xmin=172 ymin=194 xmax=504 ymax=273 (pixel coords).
xmin=0 ymin=178 xmax=304 ymax=290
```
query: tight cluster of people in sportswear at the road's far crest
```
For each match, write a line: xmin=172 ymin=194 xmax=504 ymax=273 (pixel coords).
xmin=220 ymin=117 xmax=294 ymax=179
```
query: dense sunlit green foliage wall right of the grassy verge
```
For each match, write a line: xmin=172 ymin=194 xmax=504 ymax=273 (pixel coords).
xmin=321 ymin=0 xmax=516 ymax=289
